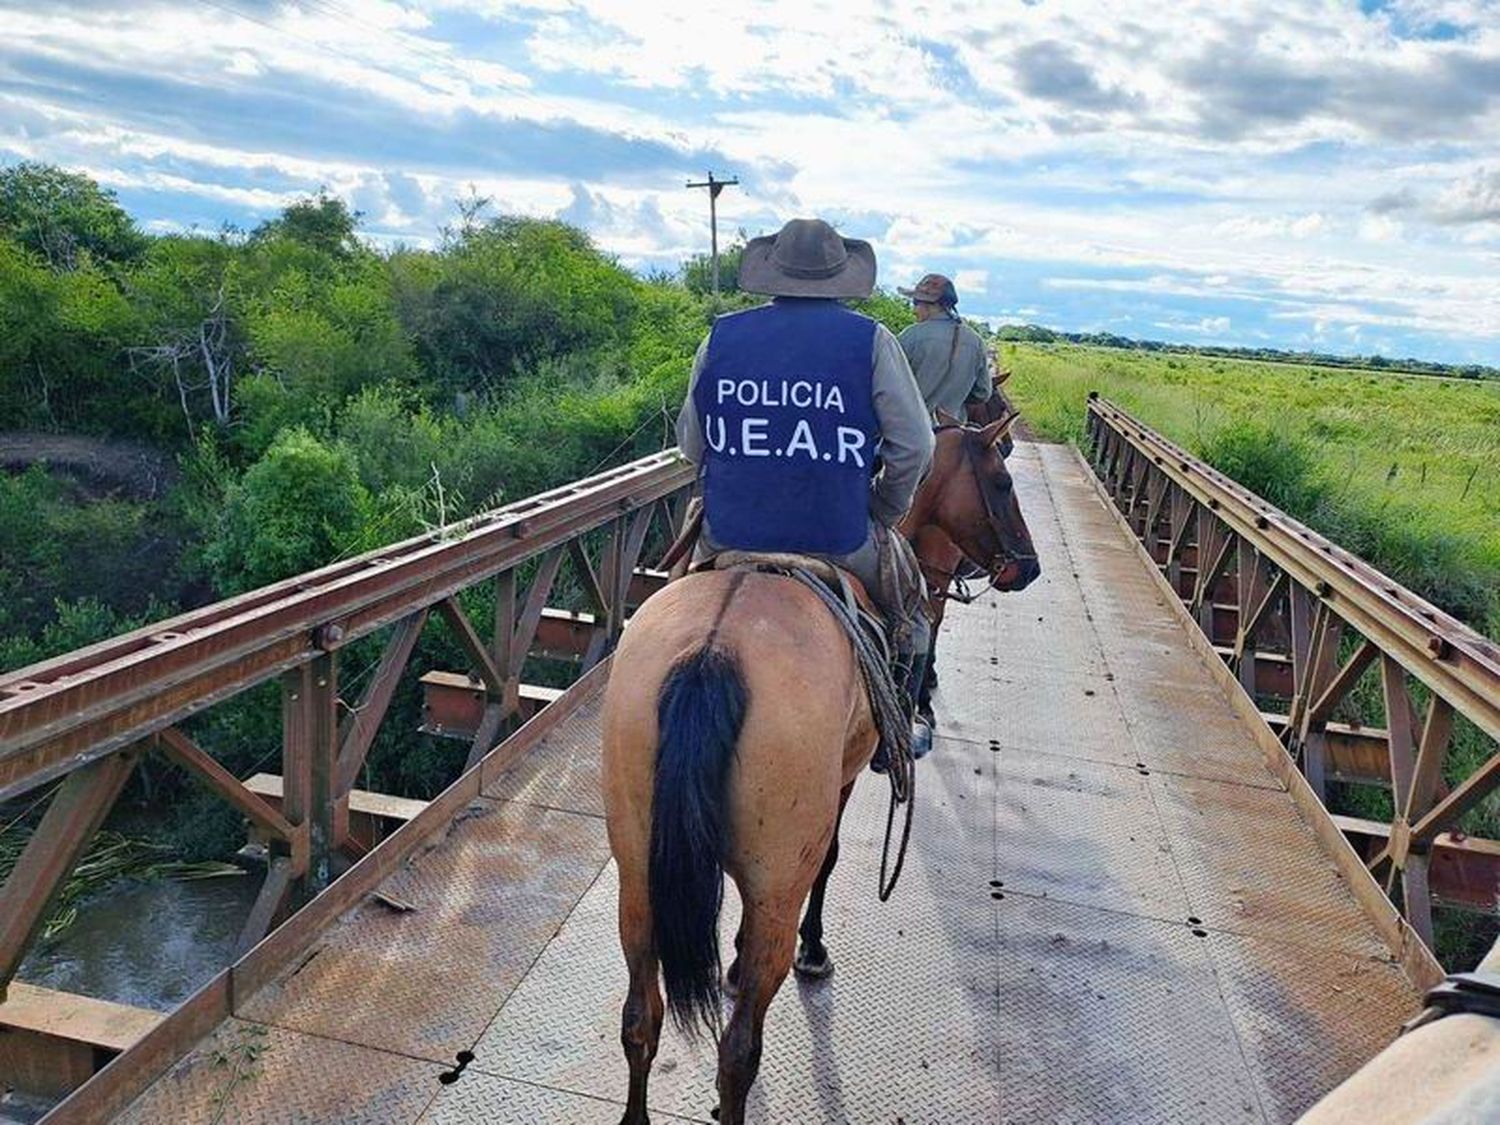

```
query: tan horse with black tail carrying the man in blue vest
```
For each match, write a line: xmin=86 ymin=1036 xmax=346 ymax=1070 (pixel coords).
xmin=603 ymin=423 xmax=1038 ymax=1125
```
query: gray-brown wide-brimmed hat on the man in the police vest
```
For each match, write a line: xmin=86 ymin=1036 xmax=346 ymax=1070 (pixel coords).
xmin=740 ymin=219 xmax=875 ymax=297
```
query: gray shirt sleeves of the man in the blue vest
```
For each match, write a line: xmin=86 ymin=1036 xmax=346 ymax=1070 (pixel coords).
xmin=677 ymin=306 xmax=933 ymax=527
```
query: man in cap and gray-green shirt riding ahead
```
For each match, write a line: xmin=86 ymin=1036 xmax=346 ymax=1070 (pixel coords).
xmin=897 ymin=273 xmax=990 ymax=419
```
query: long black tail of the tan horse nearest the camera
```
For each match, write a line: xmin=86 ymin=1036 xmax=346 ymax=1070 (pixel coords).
xmin=650 ymin=645 xmax=747 ymax=1035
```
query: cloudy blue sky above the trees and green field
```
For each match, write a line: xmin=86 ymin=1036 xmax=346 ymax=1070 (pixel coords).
xmin=0 ymin=0 xmax=1500 ymax=365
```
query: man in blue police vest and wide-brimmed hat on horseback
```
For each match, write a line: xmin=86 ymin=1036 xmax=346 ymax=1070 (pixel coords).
xmin=677 ymin=219 xmax=933 ymax=756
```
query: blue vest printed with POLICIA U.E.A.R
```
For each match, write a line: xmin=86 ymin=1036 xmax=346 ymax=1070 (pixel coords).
xmin=693 ymin=297 xmax=879 ymax=555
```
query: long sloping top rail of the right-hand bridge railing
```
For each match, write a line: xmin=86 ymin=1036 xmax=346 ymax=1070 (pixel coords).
xmin=1089 ymin=398 xmax=1500 ymax=750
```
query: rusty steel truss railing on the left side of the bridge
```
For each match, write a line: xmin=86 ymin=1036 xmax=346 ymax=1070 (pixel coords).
xmin=0 ymin=450 xmax=693 ymax=1001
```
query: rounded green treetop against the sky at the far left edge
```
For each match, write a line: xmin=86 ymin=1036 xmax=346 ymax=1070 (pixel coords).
xmin=0 ymin=161 xmax=146 ymax=270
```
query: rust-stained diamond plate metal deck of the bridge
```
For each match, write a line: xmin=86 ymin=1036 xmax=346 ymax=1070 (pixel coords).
xmin=102 ymin=443 xmax=1418 ymax=1125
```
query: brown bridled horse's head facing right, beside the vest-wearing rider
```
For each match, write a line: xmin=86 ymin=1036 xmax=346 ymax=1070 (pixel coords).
xmin=908 ymin=411 xmax=1041 ymax=591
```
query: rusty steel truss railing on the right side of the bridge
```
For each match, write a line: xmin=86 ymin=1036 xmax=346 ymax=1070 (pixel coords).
xmin=1088 ymin=396 xmax=1500 ymax=948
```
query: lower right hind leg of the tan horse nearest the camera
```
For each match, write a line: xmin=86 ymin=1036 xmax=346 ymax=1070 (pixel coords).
xmin=719 ymin=900 xmax=797 ymax=1125
